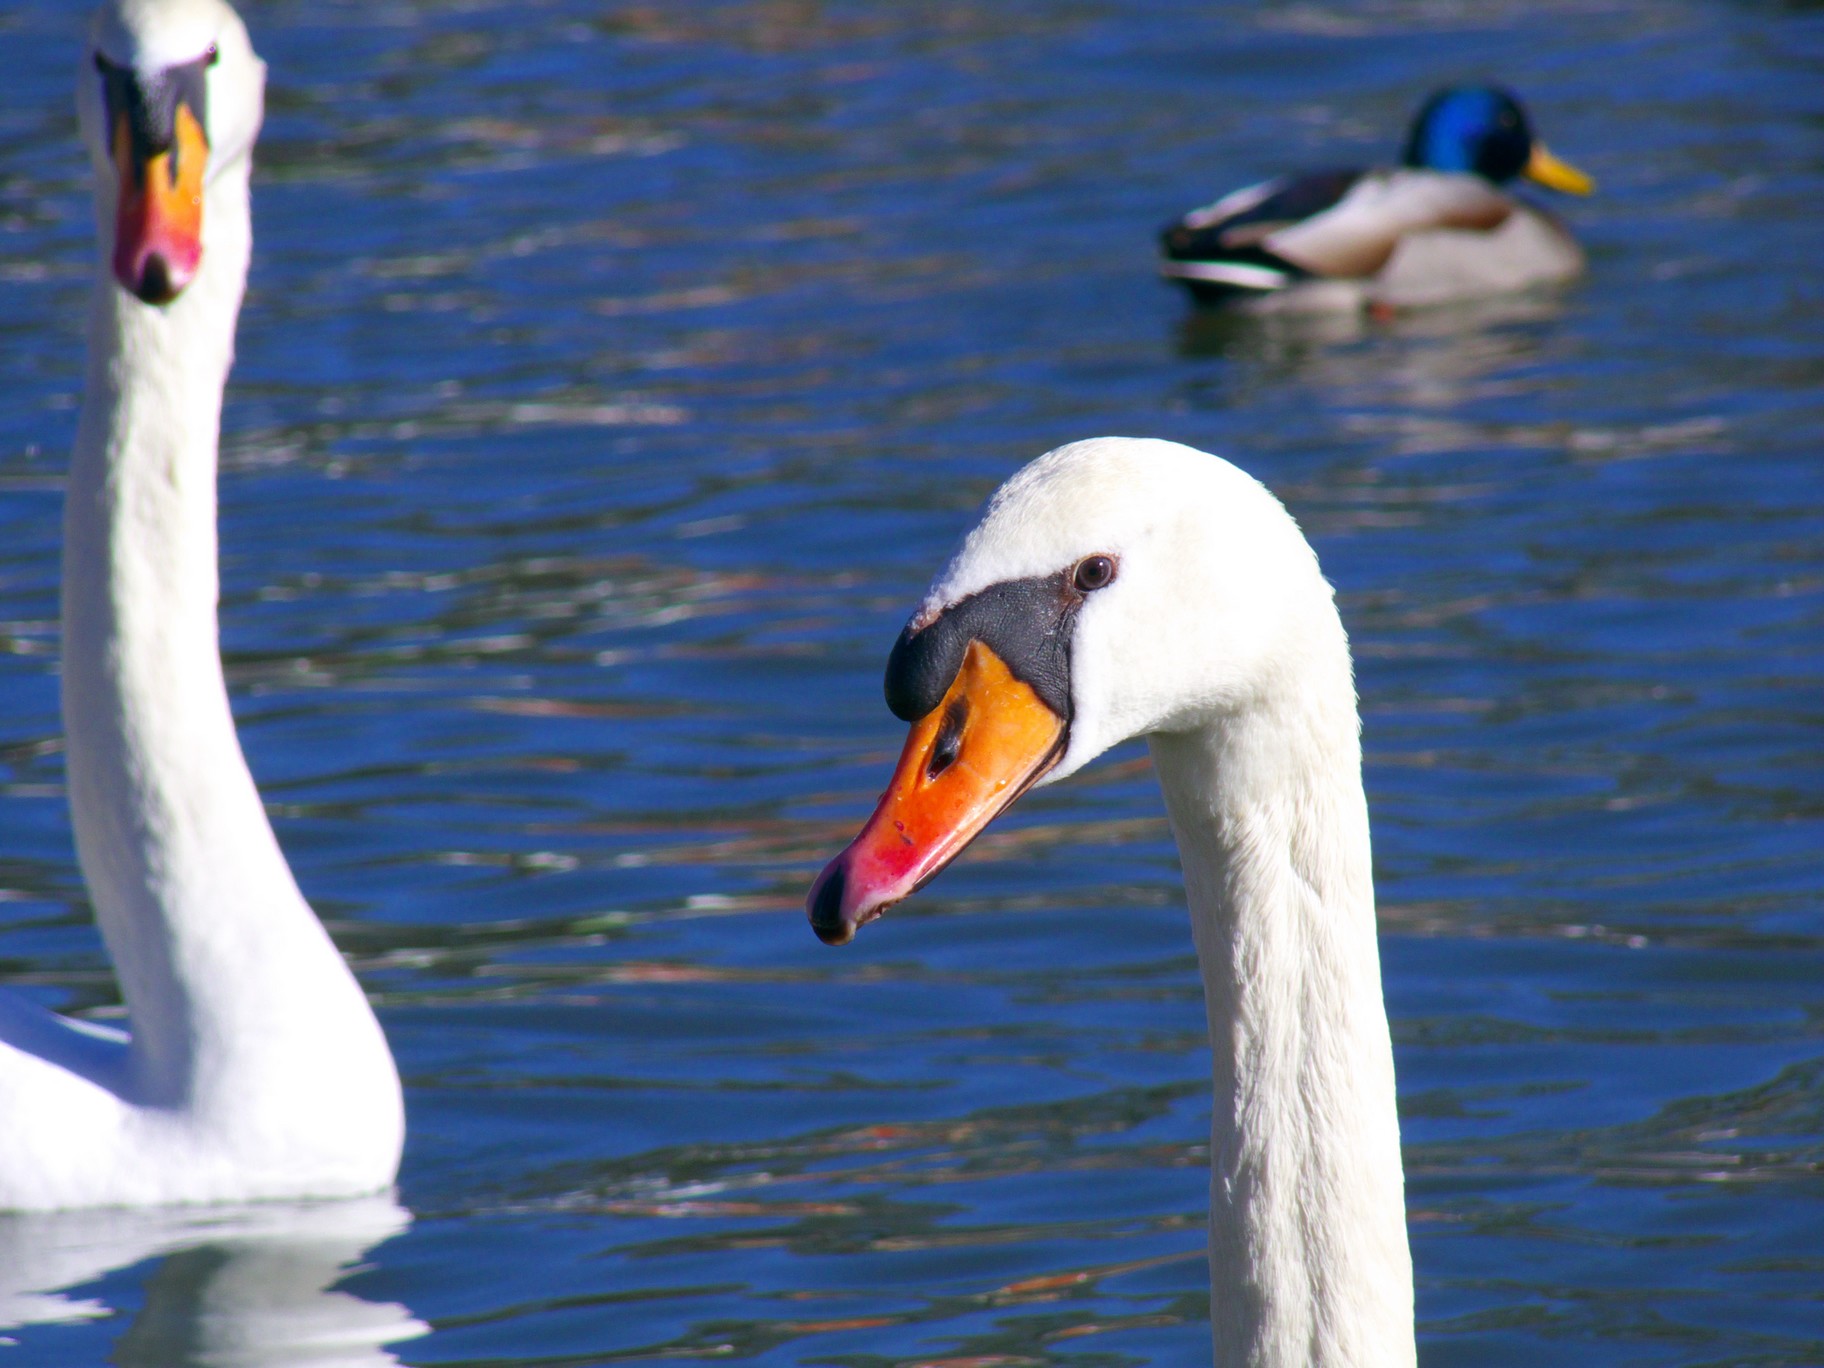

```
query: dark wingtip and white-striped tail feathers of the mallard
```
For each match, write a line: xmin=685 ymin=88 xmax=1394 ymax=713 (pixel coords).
xmin=1160 ymin=168 xmax=1364 ymax=290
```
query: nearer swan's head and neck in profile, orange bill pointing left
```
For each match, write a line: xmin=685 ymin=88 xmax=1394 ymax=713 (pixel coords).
xmin=810 ymin=438 xmax=1415 ymax=1368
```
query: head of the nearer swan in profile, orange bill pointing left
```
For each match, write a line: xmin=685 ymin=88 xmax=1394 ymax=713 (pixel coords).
xmin=808 ymin=438 xmax=1353 ymax=945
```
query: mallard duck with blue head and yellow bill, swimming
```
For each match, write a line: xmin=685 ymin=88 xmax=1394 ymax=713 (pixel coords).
xmin=1160 ymin=86 xmax=1596 ymax=306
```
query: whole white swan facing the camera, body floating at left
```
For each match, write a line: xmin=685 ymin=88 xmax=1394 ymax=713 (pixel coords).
xmin=0 ymin=0 xmax=405 ymax=1209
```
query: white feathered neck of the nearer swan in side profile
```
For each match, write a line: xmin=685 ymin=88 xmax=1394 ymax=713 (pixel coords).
xmin=1151 ymin=613 xmax=1415 ymax=1368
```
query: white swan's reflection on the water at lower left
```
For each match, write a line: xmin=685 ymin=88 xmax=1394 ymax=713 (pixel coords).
xmin=0 ymin=1197 xmax=427 ymax=1368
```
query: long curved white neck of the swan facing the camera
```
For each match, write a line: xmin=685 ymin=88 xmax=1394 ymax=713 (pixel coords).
xmin=62 ymin=161 xmax=398 ymax=1116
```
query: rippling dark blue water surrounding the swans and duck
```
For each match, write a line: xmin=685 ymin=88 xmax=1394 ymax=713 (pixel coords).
xmin=0 ymin=0 xmax=1824 ymax=1368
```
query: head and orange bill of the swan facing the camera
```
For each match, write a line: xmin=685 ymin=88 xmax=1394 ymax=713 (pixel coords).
xmin=77 ymin=0 xmax=266 ymax=305
